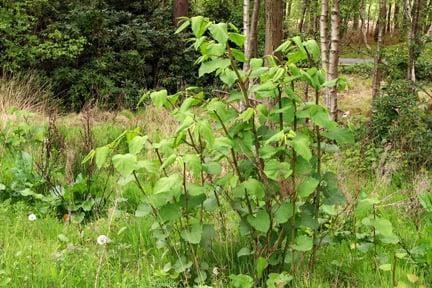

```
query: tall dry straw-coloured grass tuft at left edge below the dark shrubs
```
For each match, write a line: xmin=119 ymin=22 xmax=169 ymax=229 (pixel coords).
xmin=0 ymin=73 xmax=51 ymax=117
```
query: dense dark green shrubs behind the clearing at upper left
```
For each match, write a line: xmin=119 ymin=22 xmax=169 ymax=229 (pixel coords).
xmin=0 ymin=0 xmax=196 ymax=109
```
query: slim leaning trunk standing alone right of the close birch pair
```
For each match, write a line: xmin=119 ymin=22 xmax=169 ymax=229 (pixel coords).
xmin=372 ymin=0 xmax=386 ymax=99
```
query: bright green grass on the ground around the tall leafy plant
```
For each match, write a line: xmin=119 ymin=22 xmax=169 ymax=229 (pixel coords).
xmin=0 ymin=110 xmax=432 ymax=288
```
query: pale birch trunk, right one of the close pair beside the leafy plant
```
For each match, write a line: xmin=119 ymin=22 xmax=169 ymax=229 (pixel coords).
xmin=328 ymin=0 xmax=340 ymax=121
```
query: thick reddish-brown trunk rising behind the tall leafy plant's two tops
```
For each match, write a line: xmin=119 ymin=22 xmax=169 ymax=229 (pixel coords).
xmin=264 ymin=0 xmax=284 ymax=56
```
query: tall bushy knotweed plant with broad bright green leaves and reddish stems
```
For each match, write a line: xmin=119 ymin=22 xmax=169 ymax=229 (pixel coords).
xmin=86 ymin=17 xmax=353 ymax=287
